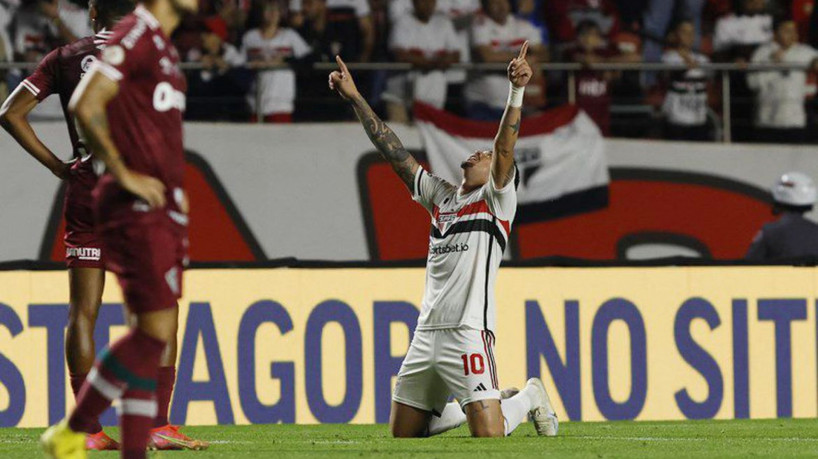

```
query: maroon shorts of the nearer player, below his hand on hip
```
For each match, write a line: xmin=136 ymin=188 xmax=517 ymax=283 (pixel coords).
xmin=100 ymin=210 xmax=187 ymax=313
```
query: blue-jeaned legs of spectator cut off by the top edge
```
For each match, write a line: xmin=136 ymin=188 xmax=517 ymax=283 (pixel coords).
xmin=643 ymin=0 xmax=706 ymax=62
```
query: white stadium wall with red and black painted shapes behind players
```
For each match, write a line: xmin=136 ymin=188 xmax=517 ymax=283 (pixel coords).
xmin=0 ymin=123 xmax=818 ymax=261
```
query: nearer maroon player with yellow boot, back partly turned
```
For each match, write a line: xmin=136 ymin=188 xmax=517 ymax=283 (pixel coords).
xmin=42 ymin=0 xmax=206 ymax=458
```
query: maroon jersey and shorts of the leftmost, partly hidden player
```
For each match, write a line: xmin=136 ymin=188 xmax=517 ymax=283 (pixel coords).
xmin=21 ymin=30 xmax=111 ymax=269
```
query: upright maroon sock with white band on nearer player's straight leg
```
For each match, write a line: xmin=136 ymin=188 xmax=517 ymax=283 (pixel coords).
xmin=119 ymin=389 xmax=157 ymax=459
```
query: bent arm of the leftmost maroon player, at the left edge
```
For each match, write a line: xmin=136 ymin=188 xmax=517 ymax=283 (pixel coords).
xmin=0 ymin=84 xmax=70 ymax=179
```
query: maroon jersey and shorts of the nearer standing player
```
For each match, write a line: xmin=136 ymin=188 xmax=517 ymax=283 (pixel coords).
xmin=94 ymin=5 xmax=187 ymax=312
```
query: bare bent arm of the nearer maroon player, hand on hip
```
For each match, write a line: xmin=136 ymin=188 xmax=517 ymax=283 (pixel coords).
xmin=69 ymin=70 xmax=165 ymax=208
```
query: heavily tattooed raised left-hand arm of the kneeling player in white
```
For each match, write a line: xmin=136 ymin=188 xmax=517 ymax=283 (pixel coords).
xmin=329 ymin=56 xmax=420 ymax=192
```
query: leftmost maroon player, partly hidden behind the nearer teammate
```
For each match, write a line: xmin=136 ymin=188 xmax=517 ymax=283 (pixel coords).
xmin=0 ymin=0 xmax=134 ymax=450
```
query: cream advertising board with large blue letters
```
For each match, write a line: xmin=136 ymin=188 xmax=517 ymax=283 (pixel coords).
xmin=0 ymin=267 xmax=818 ymax=427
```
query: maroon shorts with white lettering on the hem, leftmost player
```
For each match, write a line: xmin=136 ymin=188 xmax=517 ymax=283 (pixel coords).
xmin=63 ymin=160 xmax=105 ymax=269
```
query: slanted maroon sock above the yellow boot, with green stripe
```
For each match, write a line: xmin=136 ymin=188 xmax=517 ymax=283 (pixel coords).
xmin=68 ymin=329 xmax=165 ymax=434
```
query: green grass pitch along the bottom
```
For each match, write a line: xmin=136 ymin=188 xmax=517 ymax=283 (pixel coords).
xmin=6 ymin=419 xmax=818 ymax=459
